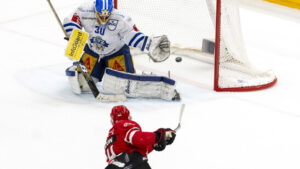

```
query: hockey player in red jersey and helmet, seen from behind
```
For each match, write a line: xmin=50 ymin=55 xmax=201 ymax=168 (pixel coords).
xmin=105 ymin=105 xmax=176 ymax=169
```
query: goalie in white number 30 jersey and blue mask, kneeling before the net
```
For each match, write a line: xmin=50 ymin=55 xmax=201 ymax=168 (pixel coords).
xmin=63 ymin=0 xmax=179 ymax=100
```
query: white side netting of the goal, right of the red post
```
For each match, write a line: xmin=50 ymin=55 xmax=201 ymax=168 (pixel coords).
xmin=217 ymin=0 xmax=276 ymax=90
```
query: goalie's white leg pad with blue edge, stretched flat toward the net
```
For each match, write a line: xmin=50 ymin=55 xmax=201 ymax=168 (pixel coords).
xmin=102 ymin=68 xmax=180 ymax=100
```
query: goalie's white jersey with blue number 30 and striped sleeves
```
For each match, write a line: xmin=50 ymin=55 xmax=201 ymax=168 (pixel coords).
xmin=63 ymin=1 xmax=149 ymax=58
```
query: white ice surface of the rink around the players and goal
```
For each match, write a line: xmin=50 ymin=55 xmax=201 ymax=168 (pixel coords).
xmin=0 ymin=0 xmax=300 ymax=169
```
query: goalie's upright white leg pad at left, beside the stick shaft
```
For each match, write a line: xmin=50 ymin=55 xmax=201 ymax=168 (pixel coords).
xmin=66 ymin=62 xmax=91 ymax=94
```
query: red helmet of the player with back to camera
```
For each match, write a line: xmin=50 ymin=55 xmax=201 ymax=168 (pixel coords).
xmin=110 ymin=105 xmax=130 ymax=124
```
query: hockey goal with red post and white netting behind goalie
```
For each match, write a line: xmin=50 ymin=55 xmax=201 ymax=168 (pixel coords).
xmin=114 ymin=0 xmax=277 ymax=91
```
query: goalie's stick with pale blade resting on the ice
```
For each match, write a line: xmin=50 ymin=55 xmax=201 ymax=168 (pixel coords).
xmin=47 ymin=0 xmax=126 ymax=102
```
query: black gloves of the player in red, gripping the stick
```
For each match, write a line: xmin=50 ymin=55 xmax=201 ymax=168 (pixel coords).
xmin=152 ymin=128 xmax=176 ymax=151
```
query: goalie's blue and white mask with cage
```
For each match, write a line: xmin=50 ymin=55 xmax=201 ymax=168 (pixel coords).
xmin=95 ymin=0 xmax=114 ymax=27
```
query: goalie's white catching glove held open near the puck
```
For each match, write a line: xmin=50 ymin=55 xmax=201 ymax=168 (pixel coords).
xmin=147 ymin=35 xmax=170 ymax=62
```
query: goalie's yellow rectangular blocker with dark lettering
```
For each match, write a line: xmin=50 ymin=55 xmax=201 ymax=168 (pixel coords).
xmin=65 ymin=29 xmax=89 ymax=61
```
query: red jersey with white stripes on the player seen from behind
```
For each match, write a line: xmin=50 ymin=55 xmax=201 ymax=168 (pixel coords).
xmin=105 ymin=120 xmax=155 ymax=163
